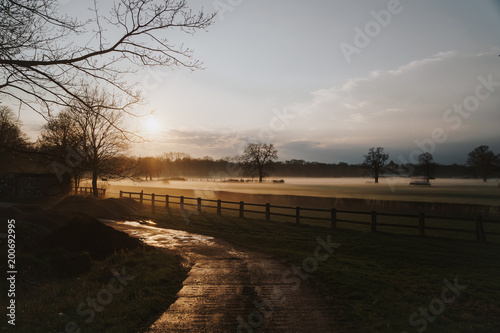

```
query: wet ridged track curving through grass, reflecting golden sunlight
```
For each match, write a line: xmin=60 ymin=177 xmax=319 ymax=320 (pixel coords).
xmin=107 ymin=222 xmax=344 ymax=333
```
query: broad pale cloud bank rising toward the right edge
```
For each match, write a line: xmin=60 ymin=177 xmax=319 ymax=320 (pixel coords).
xmin=280 ymin=52 xmax=500 ymax=162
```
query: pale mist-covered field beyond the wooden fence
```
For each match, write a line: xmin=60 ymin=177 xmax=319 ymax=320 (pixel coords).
xmin=107 ymin=177 xmax=500 ymax=206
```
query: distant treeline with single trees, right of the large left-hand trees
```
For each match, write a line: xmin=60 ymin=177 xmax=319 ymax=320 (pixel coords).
xmin=124 ymin=144 xmax=500 ymax=182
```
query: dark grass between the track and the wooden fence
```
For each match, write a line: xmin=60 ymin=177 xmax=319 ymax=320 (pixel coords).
xmin=138 ymin=208 xmax=500 ymax=332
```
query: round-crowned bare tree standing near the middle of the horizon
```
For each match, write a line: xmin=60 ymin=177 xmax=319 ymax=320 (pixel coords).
xmin=242 ymin=143 xmax=278 ymax=183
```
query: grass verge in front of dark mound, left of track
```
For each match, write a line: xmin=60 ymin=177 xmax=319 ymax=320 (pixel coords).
xmin=2 ymin=249 xmax=186 ymax=333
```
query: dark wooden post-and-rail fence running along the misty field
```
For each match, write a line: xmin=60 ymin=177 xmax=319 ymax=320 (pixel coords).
xmin=120 ymin=191 xmax=500 ymax=242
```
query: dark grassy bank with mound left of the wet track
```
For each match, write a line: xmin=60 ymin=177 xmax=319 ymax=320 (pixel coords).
xmin=0 ymin=197 xmax=187 ymax=333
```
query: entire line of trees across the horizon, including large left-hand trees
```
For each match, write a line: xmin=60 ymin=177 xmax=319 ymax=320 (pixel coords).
xmin=0 ymin=106 xmax=500 ymax=195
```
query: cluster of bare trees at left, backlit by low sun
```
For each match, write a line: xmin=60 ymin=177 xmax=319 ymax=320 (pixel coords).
xmin=0 ymin=88 xmax=134 ymax=196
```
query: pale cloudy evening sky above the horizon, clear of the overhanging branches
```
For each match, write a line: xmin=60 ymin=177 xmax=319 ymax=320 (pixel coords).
xmin=15 ymin=0 xmax=500 ymax=164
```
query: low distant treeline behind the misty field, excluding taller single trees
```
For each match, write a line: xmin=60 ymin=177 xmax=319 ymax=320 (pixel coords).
xmin=132 ymin=153 xmax=482 ymax=179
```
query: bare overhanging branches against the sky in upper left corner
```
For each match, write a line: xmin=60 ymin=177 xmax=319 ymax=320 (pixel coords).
xmin=0 ymin=0 xmax=215 ymax=115
